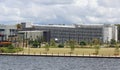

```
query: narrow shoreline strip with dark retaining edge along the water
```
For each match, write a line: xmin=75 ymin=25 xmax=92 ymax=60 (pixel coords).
xmin=0 ymin=53 xmax=120 ymax=59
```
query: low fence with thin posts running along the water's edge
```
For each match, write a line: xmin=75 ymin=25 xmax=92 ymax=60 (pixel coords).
xmin=0 ymin=52 xmax=120 ymax=58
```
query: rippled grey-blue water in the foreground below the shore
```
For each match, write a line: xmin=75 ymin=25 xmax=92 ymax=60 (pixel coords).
xmin=0 ymin=56 xmax=120 ymax=70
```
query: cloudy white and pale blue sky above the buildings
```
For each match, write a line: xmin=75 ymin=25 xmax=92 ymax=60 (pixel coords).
xmin=0 ymin=0 xmax=120 ymax=24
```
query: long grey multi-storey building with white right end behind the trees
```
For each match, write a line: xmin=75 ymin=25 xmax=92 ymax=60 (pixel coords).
xmin=20 ymin=24 xmax=117 ymax=43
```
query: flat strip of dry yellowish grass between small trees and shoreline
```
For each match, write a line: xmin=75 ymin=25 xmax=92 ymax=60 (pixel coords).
xmin=19 ymin=48 xmax=118 ymax=56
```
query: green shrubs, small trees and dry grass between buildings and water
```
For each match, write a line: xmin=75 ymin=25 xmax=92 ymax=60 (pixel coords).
xmin=0 ymin=39 xmax=120 ymax=56
